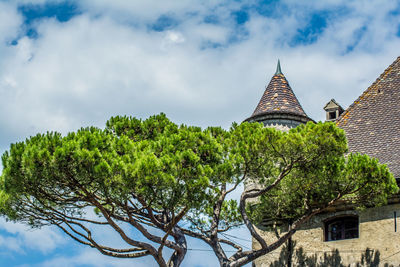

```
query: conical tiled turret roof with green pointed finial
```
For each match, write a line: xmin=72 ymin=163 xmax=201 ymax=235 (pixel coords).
xmin=248 ymin=60 xmax=311 ymax=120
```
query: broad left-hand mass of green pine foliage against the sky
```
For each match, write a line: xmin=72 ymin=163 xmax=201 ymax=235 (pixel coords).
xmin=1 ymin=114 xmax=238 ymax=225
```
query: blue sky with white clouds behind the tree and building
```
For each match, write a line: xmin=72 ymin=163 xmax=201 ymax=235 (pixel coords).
xmin=0 ymin=0 xmax=400 ymax=266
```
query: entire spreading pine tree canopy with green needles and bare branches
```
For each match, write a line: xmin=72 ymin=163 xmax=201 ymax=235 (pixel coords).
xmin=0 ymin=114 xmax=398 ymax=266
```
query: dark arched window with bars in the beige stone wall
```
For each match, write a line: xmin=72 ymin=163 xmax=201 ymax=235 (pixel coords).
xmin=325 ymin=216 xmax=358 ymax=241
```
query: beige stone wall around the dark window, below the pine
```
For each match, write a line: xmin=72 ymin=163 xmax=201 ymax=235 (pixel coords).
xmin=253 ymin=204 xmax=400 ymax=267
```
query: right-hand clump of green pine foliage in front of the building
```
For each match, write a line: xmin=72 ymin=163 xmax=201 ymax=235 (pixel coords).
xmin=250 ymin=123 xmax=398 ymax=225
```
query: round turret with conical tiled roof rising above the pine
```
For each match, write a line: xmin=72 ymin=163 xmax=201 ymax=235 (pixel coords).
xmin=245 ymin=60 xmax=312 ymax=131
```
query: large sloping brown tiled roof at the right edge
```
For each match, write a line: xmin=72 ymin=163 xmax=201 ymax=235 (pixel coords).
xmin=337 ymin=57 xmax=400 ymax=178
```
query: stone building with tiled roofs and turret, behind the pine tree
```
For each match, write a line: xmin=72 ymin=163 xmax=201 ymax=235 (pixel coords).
xmin=246 ymin=57 xmax=400 ymax=267
